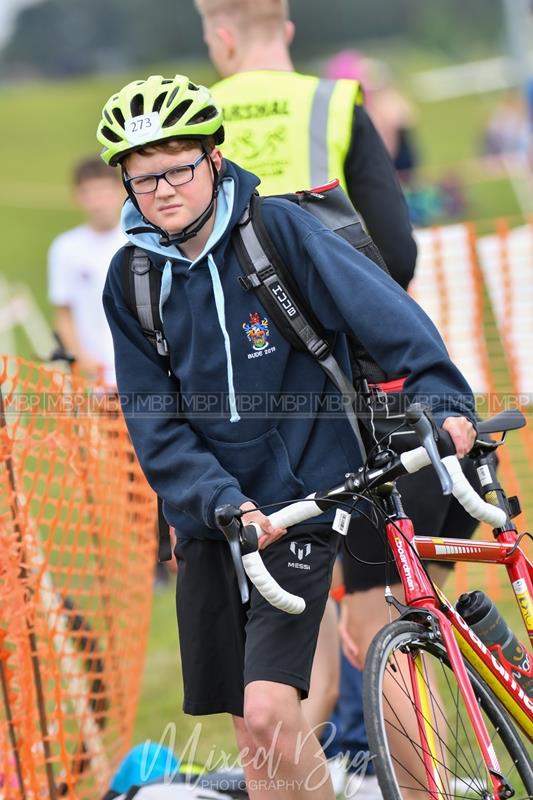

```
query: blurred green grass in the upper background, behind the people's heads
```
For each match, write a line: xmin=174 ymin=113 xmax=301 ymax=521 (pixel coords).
xmin=0 ymin=54 xmax=519 ymax=326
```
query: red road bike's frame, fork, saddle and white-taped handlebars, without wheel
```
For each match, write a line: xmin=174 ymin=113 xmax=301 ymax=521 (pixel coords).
xmin=217 ymin=404 xmax=533 ymax=800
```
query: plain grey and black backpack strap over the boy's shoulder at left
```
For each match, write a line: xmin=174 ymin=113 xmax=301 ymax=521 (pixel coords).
xmin=122 ymin=247 xmax=172 ymax=561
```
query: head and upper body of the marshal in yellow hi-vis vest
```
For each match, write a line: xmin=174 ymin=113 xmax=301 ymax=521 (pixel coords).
xmin=195 ymin=0 xmax=416 ymax=289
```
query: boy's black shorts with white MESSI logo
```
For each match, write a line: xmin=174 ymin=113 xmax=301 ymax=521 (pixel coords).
xmin=175 ymin=524 xmax=337 ymax=716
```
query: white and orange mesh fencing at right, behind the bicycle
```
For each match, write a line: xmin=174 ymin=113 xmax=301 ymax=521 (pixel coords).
xmin=412 ymin=216 xmax=533 ymax=599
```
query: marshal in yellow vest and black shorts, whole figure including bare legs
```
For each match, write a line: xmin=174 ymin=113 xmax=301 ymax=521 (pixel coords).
xmin=195 ymin=0 xmax=475 ymax=791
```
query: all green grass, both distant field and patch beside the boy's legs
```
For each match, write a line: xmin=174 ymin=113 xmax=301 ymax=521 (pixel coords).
xmin=0 ymin=51 xmax=519 ymax=760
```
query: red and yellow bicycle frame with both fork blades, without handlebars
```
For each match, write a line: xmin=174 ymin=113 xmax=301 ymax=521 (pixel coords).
xmin=386 ymin=510 xmax=533 ymax=797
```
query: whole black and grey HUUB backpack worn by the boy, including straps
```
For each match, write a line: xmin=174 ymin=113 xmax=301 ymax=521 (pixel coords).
xmin=121 ymin=180 xmax=403 ymax=560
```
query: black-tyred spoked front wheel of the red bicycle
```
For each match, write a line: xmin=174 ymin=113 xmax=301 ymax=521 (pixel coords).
xmin=363 ymin=620 xmax=533 ymax=800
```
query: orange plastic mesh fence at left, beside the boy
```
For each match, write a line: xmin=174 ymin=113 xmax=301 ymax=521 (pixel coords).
xmin=0 ymin=357 xmax=156 ymax=800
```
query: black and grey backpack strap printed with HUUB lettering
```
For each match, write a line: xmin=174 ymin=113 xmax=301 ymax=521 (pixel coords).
xmin=232 ymin=194 xmax=366 ymax=460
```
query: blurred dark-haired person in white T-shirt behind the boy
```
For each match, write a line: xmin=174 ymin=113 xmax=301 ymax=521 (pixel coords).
xmin=48 ymin=156 xmax=126 ymax=384
